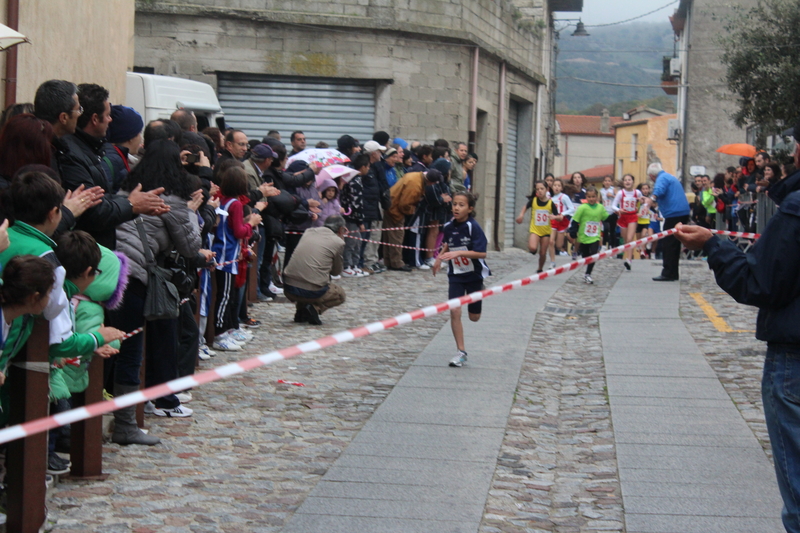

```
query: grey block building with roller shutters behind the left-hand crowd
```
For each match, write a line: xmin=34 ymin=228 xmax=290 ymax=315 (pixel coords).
xmin=135 ymin=0 xmax=582 ymax=247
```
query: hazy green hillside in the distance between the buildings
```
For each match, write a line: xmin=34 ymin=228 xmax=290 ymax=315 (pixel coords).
xmin=556 ymin=20 xmax=674 ymax=114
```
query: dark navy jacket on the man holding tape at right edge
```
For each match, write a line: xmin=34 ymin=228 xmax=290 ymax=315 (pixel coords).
xmin=703 ymin=171 xmax=800 ymax=344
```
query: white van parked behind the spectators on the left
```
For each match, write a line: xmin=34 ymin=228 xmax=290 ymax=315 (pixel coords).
xmin=125 ymin=72 xmax=224 ymax=131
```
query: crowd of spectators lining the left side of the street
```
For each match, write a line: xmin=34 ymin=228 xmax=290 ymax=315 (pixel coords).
xmin=0 ymin=80 xmax=477 ymax=474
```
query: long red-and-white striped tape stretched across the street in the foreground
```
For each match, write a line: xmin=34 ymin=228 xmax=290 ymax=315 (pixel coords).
xmin=0 ymin=228 xmax=692 ymax=444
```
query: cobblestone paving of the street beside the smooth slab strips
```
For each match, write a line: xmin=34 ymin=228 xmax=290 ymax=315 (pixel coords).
xmin=43 ymin=249 xmax=769 ymax=533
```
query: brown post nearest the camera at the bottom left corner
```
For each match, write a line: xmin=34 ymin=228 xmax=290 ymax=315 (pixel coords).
xmin=6 ymin=319 xmax=50 ymax=533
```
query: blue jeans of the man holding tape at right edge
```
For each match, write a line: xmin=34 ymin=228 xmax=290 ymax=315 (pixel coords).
xmin=761 ymin=345 xmax=800 ymax=533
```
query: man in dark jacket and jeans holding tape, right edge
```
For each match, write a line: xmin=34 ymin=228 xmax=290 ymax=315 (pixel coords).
xmin=677 ymin=124 xmax=800 ymax=533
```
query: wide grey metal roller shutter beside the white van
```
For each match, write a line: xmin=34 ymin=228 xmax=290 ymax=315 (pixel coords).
xmin=217 ymin=72 xmax=375 ymax=148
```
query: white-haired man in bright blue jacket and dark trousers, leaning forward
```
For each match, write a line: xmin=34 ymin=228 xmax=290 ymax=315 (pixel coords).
xmin=646 ymin=163 xmax=689 ymax=281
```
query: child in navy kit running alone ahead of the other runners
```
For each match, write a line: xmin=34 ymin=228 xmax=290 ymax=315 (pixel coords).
xmin=432 ymin=192 xmax=491 ymax=367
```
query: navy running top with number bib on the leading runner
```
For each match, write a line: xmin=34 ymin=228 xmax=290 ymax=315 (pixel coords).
xmin=442 ymin=217 xmax=491 ymax=282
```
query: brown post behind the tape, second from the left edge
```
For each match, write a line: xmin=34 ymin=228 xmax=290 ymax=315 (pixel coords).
xmin=69 ymin=357 xmax=108 ymax=480
